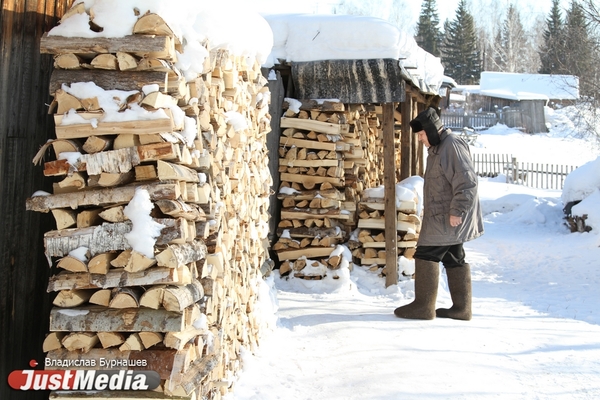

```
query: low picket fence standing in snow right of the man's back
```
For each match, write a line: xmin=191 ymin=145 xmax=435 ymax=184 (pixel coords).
xmin=473 ymin=154 xmax=577 ymax=190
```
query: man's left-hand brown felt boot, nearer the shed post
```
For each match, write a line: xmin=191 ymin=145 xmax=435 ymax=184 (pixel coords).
xmin=394 ymin=258 xmax=440 ymax=319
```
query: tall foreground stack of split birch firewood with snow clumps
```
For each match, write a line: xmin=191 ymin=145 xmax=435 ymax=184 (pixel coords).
xmin=27 ymin=8 xmax=272 ymax=399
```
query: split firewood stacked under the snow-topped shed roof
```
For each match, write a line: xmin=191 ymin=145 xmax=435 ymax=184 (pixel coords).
xmin=274 ymin=99 xmax=412 ymax=279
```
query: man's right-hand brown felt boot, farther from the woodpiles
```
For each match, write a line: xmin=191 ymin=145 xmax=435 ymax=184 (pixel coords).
xmin=436 ymin=264 xmax=472 ymax=321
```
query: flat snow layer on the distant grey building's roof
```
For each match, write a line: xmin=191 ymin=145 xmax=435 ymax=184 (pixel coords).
xmin=479 ymin=71 xmax=579 ymax=100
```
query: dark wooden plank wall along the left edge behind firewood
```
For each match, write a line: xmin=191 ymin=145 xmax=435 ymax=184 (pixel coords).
xmin=0 ymin=0 xmax=72 ymax=400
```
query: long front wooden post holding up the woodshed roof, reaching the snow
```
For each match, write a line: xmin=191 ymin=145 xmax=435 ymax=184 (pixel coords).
xmin=383 ymin=103 xmax=404 ymax=287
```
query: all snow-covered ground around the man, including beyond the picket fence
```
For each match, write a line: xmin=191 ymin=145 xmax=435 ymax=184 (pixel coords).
xmin=227 ymin=107 xmax=600 ymax=400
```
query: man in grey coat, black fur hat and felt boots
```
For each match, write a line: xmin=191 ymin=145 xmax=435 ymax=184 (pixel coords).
xmin=394 ymin=107 xmax=483 ymax=320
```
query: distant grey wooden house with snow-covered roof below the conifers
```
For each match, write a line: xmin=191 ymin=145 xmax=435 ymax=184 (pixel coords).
xmin=449 ymin=71 xmax=579 ymax=133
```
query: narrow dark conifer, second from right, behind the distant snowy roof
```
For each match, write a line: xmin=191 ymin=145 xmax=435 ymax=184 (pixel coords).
xmin=539 ymin=0 xmax=565 ymax=74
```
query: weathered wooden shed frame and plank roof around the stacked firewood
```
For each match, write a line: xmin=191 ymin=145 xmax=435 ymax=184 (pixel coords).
xmin=269 ymin=59 xmax=440 ymax=285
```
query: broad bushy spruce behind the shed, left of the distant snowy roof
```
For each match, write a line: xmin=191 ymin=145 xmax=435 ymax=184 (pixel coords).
xmin=442 ymin=0 xmax=481 ymax=85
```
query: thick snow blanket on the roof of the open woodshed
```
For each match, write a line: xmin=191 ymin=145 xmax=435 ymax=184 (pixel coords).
xmin=263 ymin=14 xmax=444 ymax=91
